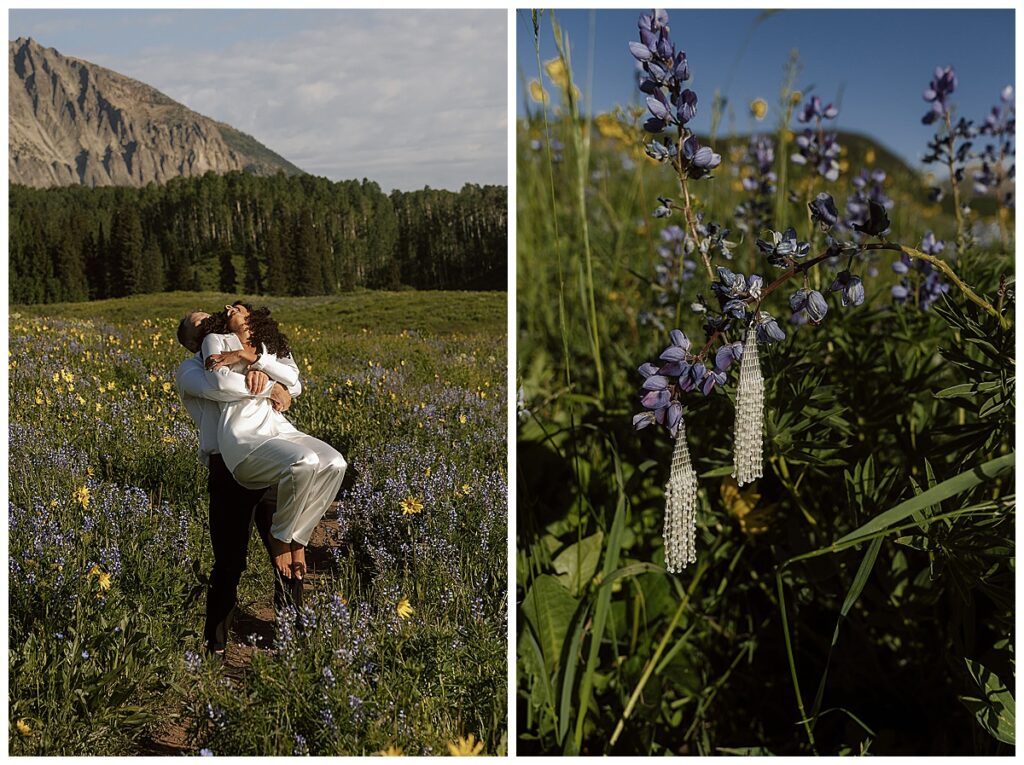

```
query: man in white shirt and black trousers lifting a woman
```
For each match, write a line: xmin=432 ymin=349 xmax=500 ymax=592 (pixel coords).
xmin=175 ymin=311 xmax=302 ymax=654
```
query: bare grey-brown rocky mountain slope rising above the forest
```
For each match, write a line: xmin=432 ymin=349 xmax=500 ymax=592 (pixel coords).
xmin=8 ymin=38 xmax=302 ymax=186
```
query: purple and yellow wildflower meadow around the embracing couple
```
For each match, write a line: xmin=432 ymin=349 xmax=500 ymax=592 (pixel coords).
xmin=8 ymin=292 xmax=508 ymax=755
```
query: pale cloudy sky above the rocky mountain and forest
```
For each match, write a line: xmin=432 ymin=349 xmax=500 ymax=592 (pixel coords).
xmin=8 ymin=9 xmax=508 ymax=192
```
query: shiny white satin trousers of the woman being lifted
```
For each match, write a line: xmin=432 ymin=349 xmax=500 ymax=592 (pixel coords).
xmin=233 ymin=433 xmax=348 ymax=545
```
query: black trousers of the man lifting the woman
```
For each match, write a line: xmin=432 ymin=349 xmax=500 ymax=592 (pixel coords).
xmin=203 ymin=454 xmax=282 ymax=650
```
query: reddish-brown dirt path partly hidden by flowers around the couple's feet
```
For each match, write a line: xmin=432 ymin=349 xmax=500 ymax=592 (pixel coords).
xmin=138 ymin=506 xmax=338 ymax=757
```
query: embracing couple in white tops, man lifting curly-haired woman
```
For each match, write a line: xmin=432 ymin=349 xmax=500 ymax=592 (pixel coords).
xmin=175 ymin=301 xmax=347 ymax=654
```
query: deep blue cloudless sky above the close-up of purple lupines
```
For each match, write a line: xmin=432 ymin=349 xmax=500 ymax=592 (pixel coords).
xmin=515 ymin=9 xmax=1016 ymax=165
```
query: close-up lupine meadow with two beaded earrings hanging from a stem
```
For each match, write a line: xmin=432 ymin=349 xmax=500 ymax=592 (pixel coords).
xmin=516 ymin=10 xmax=1015 ymax=755
